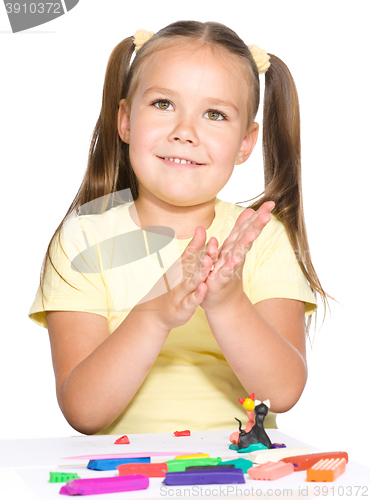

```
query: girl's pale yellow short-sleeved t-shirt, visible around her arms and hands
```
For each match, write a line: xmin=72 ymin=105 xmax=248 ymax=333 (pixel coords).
xmin=29 ymin=199 xmax=316 ymax=434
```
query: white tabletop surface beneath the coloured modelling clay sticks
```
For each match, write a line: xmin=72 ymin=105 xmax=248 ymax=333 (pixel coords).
xmin=0 ymin=429 xmax=370 ymax=500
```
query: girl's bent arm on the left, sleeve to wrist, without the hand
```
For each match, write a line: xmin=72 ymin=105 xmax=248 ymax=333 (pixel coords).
xmin=46 ymin=308 xmax=169 ymax=434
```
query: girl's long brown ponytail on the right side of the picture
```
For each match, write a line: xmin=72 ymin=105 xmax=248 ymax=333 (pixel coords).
xmin=246 ymin=54 xmax=332 ymax=332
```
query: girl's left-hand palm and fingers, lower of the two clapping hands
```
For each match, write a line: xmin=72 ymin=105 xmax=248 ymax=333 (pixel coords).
xmin=135 ymin=226 xmax=213 ymax=330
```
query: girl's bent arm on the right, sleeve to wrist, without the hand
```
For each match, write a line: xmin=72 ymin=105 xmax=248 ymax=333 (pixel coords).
xmin=206 ymin=293 xmax=307 ymax=413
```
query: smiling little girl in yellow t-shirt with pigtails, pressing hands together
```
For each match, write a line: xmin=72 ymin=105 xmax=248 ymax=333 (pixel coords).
xmin=29 ymin=21 xmax=326 ymax=434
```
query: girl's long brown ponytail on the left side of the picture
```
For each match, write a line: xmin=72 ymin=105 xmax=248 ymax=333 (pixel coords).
xmin=40 ymin=37 xmax=138 ymax=307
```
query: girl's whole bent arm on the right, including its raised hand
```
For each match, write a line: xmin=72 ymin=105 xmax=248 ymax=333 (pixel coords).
xmin=201 ymin=202 xmax=307 ymax=412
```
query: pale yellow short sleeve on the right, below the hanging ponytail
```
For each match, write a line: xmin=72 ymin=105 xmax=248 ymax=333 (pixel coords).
xmin=243 ymin=216 xmax=317 ymax=316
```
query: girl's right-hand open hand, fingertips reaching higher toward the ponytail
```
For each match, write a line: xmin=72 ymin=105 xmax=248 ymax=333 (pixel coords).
xmin=200 ymin=201 xmax=275 ymax=313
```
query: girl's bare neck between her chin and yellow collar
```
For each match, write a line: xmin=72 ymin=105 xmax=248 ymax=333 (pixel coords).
xmin=129 ymin=198 xmax=216 ymax=240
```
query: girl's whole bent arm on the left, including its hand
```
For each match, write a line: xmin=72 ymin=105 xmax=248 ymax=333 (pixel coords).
xmin=46 ymin=228 xmax=212 ymax=434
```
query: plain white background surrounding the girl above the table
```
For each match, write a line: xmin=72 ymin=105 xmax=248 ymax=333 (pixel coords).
xmin=0 ymin=0 xmax=370 ymax=465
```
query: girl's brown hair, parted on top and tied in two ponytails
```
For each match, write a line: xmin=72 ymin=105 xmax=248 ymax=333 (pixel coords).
xmin=40 ymin=21 xmax=330 ymax=332
